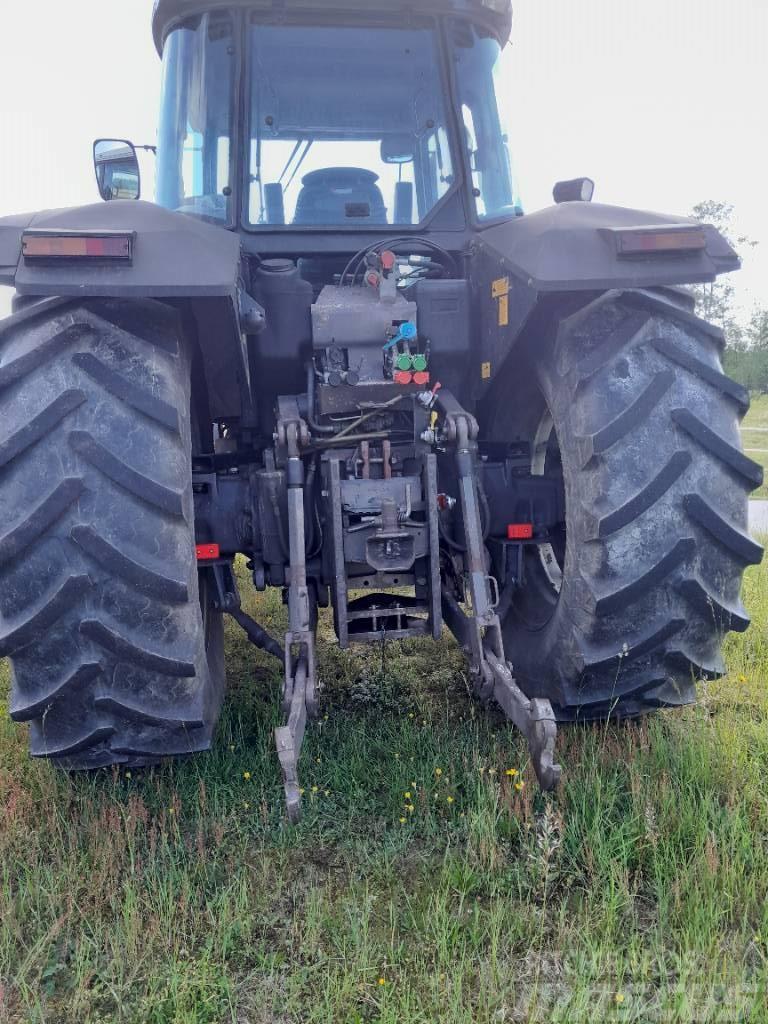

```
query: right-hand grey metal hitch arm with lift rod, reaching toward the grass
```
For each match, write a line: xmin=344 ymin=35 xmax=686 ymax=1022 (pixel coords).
xmin=436 ymin=391 xmax=562 ymax=791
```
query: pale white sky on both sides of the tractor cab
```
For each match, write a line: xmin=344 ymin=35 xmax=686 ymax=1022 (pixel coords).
xmin=0 ymin=0 xmax=768 ymax=315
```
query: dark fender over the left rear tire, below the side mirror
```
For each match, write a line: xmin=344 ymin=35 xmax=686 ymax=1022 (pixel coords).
xmin=0 ymin=200 xmax=250 ymax=419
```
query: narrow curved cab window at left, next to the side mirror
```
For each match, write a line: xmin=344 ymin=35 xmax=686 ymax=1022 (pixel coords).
xmin=157 ymin=11 xmax=236 ymax=223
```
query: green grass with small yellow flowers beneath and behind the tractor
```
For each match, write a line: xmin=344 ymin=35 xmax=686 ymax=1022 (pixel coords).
xmin=0 ymin=567 xmax=768 ymax=1024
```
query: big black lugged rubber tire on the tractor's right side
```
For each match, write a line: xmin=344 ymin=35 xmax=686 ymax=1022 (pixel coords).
xmin=486 ymin=292 xmax=762 ymax=720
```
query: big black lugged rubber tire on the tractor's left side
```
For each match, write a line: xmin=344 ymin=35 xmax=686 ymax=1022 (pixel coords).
xmin=0 ymin=299 xmax=224 ymax=769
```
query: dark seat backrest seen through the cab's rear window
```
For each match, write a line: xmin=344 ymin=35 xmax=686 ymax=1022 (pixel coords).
xmin=293 ymin=167 xmax=387 ymax=224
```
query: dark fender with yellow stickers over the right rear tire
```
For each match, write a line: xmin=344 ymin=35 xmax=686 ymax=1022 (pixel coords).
xmin=471 ymin=203 xmax=740 ymax=400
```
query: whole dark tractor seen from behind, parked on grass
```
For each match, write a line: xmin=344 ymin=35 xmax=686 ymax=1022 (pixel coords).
xmin=0 ymin=0 xmax=762 ymax=820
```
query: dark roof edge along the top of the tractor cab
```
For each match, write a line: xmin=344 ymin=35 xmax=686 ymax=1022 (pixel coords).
xmin=153 ymin=0 xmax=512 ymax=53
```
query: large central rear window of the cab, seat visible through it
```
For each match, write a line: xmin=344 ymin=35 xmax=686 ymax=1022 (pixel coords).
xmin=248 ymin=22 xmax=454 ymax=227
